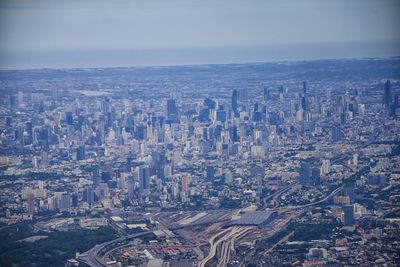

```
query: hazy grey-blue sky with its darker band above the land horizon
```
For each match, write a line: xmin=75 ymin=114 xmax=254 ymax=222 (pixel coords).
xmin=0 ymin=0 xmax=400 ymax=69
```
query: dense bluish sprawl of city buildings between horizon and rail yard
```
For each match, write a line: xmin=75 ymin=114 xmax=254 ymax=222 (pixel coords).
xmin=0 ymin=60 xmax=400 ymax=266
